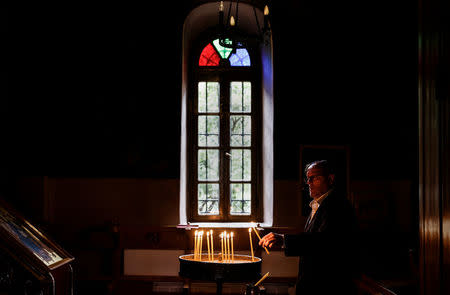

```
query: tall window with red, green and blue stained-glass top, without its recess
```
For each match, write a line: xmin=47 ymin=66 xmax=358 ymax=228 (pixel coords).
xmin=188 ymin=38 xmax=261 ymax=221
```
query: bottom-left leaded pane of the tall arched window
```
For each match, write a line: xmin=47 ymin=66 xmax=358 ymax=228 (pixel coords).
xmin=198 ymin=183 xmax=220 ymax=215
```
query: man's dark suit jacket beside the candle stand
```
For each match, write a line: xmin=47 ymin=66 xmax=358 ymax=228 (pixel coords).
xmin=284 ymin=192 xmax=359 ymax=295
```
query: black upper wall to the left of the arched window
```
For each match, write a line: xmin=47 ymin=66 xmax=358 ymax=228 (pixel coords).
xmin=8 ymin=3 xmax=183 ymax=178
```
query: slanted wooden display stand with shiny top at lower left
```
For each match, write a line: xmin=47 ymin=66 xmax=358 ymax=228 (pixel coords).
xmin=0 ymin=201 xmax=74 ymax=295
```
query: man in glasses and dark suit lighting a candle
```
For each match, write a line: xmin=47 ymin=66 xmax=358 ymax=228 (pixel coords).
xmin=259 ymin=160 xmax=358 ymax=295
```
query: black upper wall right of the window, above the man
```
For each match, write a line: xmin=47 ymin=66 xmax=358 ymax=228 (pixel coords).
xmin=272 ymin=1 xmax=417 ymax=179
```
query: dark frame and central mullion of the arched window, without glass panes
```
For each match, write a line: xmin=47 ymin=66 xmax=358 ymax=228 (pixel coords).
xmin=186 ymin=36 xmax=263 ymax=222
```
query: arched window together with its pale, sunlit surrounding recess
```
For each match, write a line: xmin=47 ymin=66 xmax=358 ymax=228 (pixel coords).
xmin=180 ymin=3 xmax=273 ymax=227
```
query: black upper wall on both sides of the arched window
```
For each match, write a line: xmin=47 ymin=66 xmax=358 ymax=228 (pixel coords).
xmin=6 ymin=1 xmax=417 ymax=179
